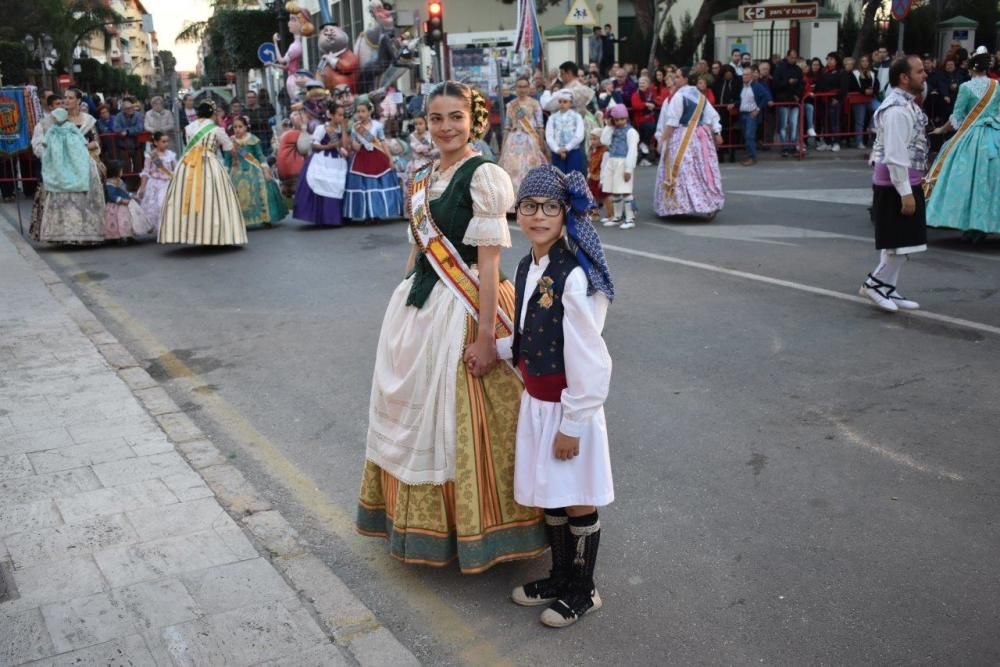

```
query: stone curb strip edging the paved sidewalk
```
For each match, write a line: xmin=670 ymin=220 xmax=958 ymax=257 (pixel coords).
xmin=0 ymin=223 xmax=420 ymax=667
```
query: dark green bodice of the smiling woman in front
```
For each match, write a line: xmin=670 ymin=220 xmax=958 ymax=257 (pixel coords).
xmin=406 ymin=155 xmax=486 ymax=310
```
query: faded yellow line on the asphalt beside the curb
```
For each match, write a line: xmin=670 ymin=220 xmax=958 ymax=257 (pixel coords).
xmin=49 ymin=255 xmax=514 ymax=665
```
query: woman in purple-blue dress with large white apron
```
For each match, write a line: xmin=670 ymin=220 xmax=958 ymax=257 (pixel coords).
xmin=292 ymin=102 xmax=351 ymax=227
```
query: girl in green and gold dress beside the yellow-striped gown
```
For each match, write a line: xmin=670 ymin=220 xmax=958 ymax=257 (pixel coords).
xmin=223 ymin=116 xmax=288 ymax=229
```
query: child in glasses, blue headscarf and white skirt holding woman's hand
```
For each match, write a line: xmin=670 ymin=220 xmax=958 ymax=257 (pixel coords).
xmin=497 ymin=166 xmax=615 ymax=628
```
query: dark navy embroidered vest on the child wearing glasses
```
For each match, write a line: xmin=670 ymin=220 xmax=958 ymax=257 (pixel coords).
xmin=511 ymin=241 xmax=580 ymax=380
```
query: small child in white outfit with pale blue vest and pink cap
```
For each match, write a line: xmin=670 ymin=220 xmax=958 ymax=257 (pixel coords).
xmin=601 ymin=104 xmax=639 ymax=229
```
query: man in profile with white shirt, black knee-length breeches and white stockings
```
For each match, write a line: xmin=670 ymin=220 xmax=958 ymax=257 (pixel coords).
xmin=859 ymin=56 xmax=927 ymax=312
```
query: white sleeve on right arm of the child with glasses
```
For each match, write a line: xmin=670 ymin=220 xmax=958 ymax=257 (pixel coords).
xmin=559 ymin=268 xmax=611 ymax=438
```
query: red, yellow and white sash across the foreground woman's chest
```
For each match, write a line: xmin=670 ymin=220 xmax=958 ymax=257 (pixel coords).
xmin=409 ymin=164 xmax=514 ymax=338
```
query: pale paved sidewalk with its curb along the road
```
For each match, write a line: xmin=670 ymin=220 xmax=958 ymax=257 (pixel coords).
xmin=0 ymin=222 xmax=418 ymax=667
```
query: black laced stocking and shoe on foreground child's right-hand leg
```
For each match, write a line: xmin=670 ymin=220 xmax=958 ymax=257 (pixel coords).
xmin=539 ymin=512 xmax=604 ymax=628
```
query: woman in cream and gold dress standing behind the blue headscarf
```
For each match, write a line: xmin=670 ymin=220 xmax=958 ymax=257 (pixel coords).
xmin=500 ymin=77 xmax=549 ymax=192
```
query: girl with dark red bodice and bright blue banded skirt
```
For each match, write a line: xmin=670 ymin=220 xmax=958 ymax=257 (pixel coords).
xmin=344 ymin=95 xmax=403 ymax=222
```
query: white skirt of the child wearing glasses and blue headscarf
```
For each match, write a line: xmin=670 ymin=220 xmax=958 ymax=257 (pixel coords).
xmin=514 ymin=392 xmax=615 ymax=509
